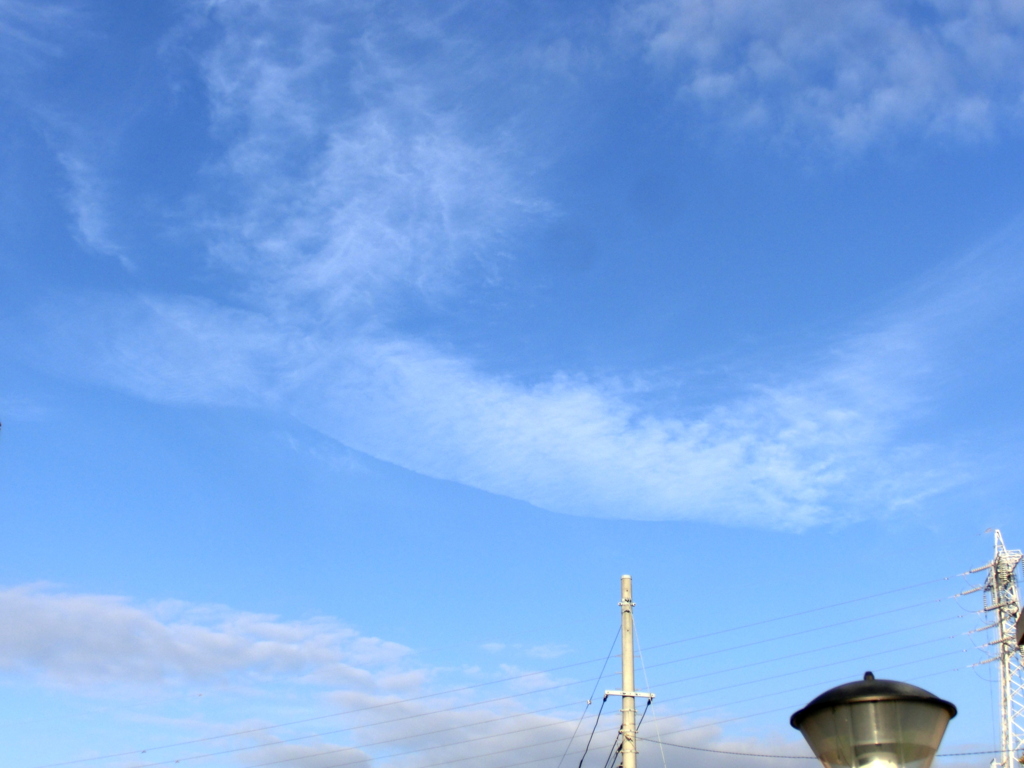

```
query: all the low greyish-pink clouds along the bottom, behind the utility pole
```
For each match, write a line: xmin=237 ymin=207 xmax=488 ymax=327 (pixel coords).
xmin=0 ymin=585 xmax=851 ymax=768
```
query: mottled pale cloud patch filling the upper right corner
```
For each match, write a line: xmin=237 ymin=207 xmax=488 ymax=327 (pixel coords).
xmin=621 ymin=0 xmax=1024 ymax=147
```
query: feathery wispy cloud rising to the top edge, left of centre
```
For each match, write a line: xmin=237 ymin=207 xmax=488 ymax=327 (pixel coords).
xmin=193 ymin=2 xmax=544 ymax=319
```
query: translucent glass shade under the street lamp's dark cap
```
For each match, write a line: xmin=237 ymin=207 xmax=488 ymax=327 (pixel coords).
xmin=798 ymin=699 xmax=955 ymax=768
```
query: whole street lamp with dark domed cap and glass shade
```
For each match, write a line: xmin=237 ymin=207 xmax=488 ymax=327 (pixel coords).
xmin=790 ymin=672 xmax=956 ymax=768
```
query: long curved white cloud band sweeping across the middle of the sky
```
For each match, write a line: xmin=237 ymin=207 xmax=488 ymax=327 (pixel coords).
xmin=46 ymin=208 xmax=1024 ymax=528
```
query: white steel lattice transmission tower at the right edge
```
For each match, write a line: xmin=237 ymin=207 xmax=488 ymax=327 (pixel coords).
xmin=978 ymin=530 xmax=1024 ymax=768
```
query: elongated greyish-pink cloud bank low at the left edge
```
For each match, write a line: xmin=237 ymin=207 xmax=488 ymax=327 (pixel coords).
xmin=0 ymin=586 xmax=409 ymax=690
